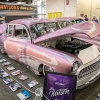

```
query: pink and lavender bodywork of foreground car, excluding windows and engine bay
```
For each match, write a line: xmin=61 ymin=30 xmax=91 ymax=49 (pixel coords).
xmin=0 ymin=19 xmax=100 ymax=88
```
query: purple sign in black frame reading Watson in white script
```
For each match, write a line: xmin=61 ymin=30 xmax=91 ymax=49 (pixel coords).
xmin=43 ymin=72 xmax=77 ymax=100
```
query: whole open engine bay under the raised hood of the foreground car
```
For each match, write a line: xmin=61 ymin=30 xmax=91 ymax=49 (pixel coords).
xmin=38 ymin=36 xmax=92 ymax=55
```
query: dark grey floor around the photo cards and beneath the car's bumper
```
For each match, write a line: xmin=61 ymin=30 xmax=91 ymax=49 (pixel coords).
xmin=0 ymin=53 xmax=100 ymax=100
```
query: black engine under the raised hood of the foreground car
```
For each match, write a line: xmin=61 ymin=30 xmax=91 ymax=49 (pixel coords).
xmin=55 ymin=37 xmax=91 ymax=55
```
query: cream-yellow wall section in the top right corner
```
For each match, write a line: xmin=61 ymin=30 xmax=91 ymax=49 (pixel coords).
xmin=77 ymin=0 xmax=100 ymax=21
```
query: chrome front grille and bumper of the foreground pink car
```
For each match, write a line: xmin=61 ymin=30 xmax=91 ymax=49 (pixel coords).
xmin=75 ymin=56 xmax=100 ymax=89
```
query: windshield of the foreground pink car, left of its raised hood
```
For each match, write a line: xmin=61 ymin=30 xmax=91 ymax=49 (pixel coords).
xmin=30 ymin=22 xmax=60 ymax=37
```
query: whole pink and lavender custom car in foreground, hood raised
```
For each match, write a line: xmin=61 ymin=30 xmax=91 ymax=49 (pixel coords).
xmin=0 ymin=19 xmax=100 ymax=89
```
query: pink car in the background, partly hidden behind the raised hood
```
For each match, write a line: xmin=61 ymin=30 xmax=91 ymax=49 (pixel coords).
xmin=55 ymin=17 xmax=84 ymax=28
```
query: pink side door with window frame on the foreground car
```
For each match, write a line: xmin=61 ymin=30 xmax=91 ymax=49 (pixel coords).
xmin=5 ymin=24 xmax=31 ymax=62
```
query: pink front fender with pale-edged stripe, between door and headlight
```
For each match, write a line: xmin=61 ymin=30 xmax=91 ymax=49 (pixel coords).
xmin=26 ymin=44 xmax=75 ymax=73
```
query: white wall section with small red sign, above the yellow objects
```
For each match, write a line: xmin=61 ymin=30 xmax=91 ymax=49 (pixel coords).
xmin=46 ymin=0 xmax=77 ymax=17
